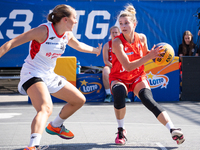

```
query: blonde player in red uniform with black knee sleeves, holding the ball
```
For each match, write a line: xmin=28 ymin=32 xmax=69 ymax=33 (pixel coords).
xmin=109 ymin=5 xmax=185 ymax=144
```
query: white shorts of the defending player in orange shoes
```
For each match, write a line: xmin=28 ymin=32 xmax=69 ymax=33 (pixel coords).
xmin=18 ymin=72 xmax=67 ymax=95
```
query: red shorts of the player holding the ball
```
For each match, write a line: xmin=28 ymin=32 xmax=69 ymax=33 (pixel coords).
xmin=110 ymin=73 xmax=149 ymax=92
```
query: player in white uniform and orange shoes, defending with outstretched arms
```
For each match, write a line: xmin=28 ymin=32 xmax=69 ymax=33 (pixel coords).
xmin=0 ymin=5 xmax=102 ymax=150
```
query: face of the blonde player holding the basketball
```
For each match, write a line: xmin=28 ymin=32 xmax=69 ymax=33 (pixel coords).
xmin=119 ymin=16 xmax=135 ymax=34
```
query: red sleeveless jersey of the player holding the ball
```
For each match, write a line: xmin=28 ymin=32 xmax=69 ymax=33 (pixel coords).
xmin=109 ymin=32 xmax=146 ymax=84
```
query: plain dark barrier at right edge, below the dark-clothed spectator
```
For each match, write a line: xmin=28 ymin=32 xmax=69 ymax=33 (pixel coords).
xmin=181 ymin=56 xmax=200 ymax=101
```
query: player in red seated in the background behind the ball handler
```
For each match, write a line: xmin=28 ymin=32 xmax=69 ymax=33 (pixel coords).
xmin=102 ymin=26 xmax=131 ymax=103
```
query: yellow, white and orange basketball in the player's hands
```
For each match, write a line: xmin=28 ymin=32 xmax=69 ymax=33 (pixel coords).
xmin=153 ymin=43 xmax=174 ymax=66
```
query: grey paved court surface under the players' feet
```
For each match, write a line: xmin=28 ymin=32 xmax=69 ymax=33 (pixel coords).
xmin=0 ymin=94 xmax=200 ymax=150
